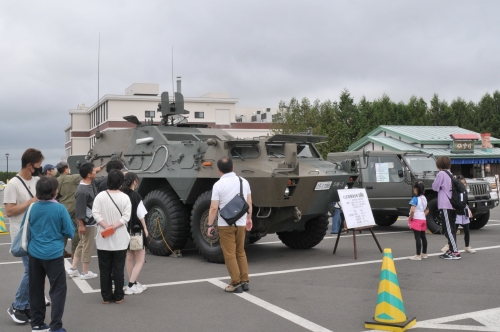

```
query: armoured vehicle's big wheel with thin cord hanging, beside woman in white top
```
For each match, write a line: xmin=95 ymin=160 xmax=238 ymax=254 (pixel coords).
xmin=144 ymin=189 xmax=189 ymax=256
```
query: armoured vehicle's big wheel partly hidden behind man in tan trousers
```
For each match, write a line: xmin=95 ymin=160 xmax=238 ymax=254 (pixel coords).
xmin=191 ymin=190 xmax=224 ymax=263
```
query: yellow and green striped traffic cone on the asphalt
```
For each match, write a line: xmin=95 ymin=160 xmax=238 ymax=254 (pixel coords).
xmin=365 ymin=248 xmax=417 ymax=332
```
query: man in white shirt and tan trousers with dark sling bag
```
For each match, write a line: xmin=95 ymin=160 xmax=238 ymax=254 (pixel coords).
xmin=207 ymin=158 xmax=252 ymax=293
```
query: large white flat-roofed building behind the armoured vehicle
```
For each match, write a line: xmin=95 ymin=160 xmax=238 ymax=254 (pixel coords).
xmin=64 ymin=81 xmax=278 ymax=156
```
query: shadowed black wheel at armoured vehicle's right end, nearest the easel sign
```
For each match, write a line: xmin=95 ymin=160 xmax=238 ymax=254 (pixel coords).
xmin=276 ymin=215 xmax=328 ymax=249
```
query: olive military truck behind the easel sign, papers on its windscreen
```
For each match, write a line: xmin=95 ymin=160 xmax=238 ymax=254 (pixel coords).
xmin=328 ymin=151 xmax=498 ymax=233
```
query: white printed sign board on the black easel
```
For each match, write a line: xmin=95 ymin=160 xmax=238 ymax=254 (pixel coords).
xmin=338 ymin=188 xmax=375 ymax=229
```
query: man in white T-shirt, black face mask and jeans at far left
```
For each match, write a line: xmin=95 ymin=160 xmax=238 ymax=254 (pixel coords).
xmin=3 ymin=148 xmax=44 ymax=324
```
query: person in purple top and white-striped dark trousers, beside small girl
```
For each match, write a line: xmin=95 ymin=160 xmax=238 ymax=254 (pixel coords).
xmin=432 ymin=156 xmax=462 ymax=259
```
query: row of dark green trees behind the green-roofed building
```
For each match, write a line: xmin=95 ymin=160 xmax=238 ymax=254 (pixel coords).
xmin=271 ymin=90 xmax=500 ymax=157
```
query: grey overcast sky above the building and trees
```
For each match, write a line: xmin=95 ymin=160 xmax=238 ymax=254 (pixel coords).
xmin=0 ymin=0 xmax=500 ymax=171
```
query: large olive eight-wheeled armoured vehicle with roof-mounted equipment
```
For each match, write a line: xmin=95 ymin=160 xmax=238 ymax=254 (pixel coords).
xmin=68 ymin=92 xmax=357 ymax=262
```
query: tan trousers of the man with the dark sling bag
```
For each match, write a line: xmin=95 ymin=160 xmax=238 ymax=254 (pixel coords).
xmin=219 ymin=226 xmax=248 ymax=285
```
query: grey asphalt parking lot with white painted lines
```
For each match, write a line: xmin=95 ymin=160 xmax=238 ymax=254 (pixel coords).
xmin=0 ymin=189 xmax=500 ymax=332
